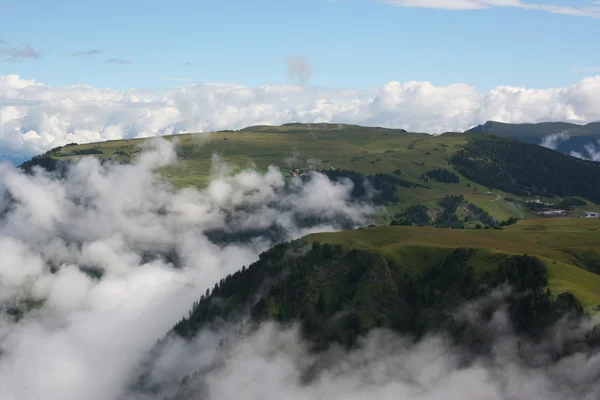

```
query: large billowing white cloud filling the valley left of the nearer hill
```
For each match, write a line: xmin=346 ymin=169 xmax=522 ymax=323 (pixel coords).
xmin=0 ymin=138 xmax=374 ymax=400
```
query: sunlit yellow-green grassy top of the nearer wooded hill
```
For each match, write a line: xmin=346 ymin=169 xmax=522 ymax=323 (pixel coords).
xmin=310 ymin=218 xmax=600 ymax=307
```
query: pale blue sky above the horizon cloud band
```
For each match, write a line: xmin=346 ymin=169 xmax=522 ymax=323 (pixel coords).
xmin=0 ymin=0 xmax=600 ymax=90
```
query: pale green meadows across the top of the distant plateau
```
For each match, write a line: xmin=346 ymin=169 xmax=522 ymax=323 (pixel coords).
xmin=45 ymin=124 xmax=544 ymax=219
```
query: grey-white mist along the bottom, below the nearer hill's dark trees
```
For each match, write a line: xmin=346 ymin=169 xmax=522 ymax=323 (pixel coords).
xmin=130 ymin=292 xmax=600 ymax=400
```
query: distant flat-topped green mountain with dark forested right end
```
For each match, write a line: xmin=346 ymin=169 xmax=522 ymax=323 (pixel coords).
xmin=14 ymin=123 xmax=600 ymax=222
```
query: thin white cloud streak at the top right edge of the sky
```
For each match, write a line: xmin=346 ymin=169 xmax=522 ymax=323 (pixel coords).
xmin=379 ymin=0 xmax=600 ymax=18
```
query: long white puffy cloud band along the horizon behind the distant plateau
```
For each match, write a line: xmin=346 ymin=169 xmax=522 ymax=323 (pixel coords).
xmin=0 ymin=75 xmax=600 ymax=159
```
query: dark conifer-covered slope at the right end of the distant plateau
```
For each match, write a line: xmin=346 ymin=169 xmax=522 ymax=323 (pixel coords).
xmin=450 ymin=135 xmax=600 ymax=203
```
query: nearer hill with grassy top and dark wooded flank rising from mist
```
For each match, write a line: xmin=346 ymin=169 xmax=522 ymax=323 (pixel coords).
xmin=134 ymin=219 xmax=600 ymax=399
